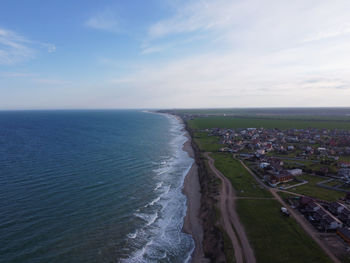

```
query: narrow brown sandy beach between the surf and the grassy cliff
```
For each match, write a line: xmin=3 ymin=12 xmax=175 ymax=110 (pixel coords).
xmin=173 ymin=115 xmax=206 ymax=263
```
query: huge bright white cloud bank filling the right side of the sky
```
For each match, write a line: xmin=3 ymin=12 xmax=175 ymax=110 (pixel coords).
xmin=116 ymin=0 xmax=350 ymax=107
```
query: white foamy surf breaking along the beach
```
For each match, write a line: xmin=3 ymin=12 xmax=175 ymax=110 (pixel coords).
xmin=122 ymin=113 xmax=194 ymax=262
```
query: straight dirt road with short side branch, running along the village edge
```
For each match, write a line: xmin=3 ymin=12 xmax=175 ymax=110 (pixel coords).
xmin=239 ymin=160 xmax=341 ymax=263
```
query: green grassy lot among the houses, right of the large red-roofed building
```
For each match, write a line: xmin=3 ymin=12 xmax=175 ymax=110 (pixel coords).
xmin=288 ymin=175 xmax=345 ymax=201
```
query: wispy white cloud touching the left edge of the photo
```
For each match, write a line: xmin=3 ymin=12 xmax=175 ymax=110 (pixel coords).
xmin=0 ymin=28 xmax=56 ymax=65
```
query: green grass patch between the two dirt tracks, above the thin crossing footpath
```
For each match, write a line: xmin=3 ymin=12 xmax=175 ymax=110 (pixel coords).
xmin=211 ymin=153 xmax=271 ymax=197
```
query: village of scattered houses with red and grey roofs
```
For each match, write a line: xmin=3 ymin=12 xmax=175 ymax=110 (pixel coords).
xmin=203 ymin=128 xmax=350 ymax=246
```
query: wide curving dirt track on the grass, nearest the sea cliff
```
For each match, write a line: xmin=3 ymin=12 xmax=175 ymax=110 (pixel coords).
xmin=205 ymin=153 xmax=256 ymax=263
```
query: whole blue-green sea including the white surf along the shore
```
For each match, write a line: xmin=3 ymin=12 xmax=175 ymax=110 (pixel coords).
xmin=0 ymin=111 xmax=194 ymax=262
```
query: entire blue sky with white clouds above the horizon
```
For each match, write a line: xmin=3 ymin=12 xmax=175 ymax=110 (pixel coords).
xmin=0 ymin=0 xmax=350 ymax=110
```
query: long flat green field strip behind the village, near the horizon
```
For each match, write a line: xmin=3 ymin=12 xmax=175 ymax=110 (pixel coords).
xmin=188 ymin=116 xmax=350 ymax=130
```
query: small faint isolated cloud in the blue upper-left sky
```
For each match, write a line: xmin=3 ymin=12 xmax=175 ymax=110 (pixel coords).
xmin=85 ymin=9 xmax=120 ymax=32
